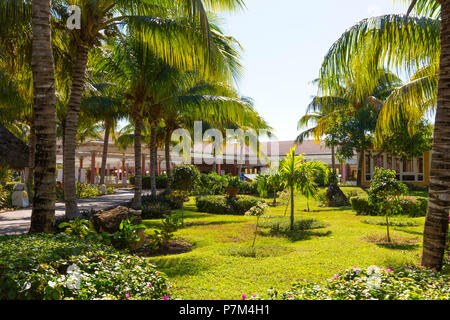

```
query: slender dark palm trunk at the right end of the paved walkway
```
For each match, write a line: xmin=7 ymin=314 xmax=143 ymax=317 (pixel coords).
xmin=131 ymin=111 xmax=142 ymax=209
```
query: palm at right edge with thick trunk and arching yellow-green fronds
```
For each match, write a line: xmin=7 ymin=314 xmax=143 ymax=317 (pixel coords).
xmin=321 ymin=0 xmax=450 ymax=270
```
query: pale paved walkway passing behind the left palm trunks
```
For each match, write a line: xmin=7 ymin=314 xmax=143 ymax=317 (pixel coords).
xmin=0 ymin=190 xmax=134 ymax=235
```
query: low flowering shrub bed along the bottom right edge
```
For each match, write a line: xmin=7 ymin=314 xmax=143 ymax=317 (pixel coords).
xmin=250 ymin=266 xmax=450 ymax=300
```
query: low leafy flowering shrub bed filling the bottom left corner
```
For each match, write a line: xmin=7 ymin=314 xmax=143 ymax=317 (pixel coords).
xmin=0 ymin=233 xmax=170 ymax=300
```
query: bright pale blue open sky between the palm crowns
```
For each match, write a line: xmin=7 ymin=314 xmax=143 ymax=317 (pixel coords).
xmin=224 ymin=0 xmax=407 ymax=140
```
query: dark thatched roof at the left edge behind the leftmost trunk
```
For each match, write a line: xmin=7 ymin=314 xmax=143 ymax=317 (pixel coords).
xmin=0 ymin=126 xmax=29 ymax=169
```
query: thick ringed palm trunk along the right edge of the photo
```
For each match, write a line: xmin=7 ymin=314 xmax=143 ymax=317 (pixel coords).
xmin=422 ymin=1 xmax=450 ymax=270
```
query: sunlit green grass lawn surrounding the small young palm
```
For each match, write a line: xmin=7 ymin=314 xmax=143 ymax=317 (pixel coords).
xmin=145 ymin=187 xmax=425 ymax=299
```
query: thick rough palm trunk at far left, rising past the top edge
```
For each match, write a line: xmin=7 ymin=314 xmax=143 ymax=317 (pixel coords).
xmin=29 ymin=0 xmax=56 ymax=233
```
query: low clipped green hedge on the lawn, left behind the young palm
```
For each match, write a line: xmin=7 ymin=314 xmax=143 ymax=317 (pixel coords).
xmin=196 ymin=196 xmax=261 ymax=215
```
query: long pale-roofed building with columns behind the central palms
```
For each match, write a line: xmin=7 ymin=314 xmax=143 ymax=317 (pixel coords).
xmin=57 ymin=139 xmax=358 ymax=184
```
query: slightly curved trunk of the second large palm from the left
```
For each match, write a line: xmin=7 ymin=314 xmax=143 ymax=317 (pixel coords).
xmin=64 ymin=45 xmax=89 ymax=219
